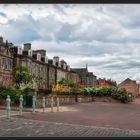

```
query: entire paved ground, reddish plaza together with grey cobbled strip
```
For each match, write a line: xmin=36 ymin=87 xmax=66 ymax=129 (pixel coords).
xmin=0 ymin=99 xmax=140 ymax=137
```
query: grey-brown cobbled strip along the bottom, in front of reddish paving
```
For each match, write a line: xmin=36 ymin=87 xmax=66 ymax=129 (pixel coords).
xmin=0 ymin=117 xmax=140 ymax=137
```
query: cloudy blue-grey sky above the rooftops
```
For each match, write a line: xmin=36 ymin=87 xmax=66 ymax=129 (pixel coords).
xmin=0 ymin=4 xmax=140 ymax=83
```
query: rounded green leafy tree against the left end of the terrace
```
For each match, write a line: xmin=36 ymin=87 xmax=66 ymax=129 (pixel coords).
xmin=13 ymin=66 xmax=31 ymax=89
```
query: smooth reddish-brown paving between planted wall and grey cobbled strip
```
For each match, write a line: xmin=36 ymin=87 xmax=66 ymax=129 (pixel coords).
xmin=13 ymin=102 xmax=140 ymax=130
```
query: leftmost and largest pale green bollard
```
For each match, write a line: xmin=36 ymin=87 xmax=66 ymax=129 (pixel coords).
xmin=6 ymin=95 xmax=11 ymax=119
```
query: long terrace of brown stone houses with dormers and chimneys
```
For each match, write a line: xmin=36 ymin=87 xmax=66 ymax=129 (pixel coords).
xmin=0 ymin=37 xmax=96 ymax=89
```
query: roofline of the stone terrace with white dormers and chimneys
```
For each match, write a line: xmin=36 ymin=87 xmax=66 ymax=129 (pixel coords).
xmin=10 ymin=43 xmax=70 ymax=71
